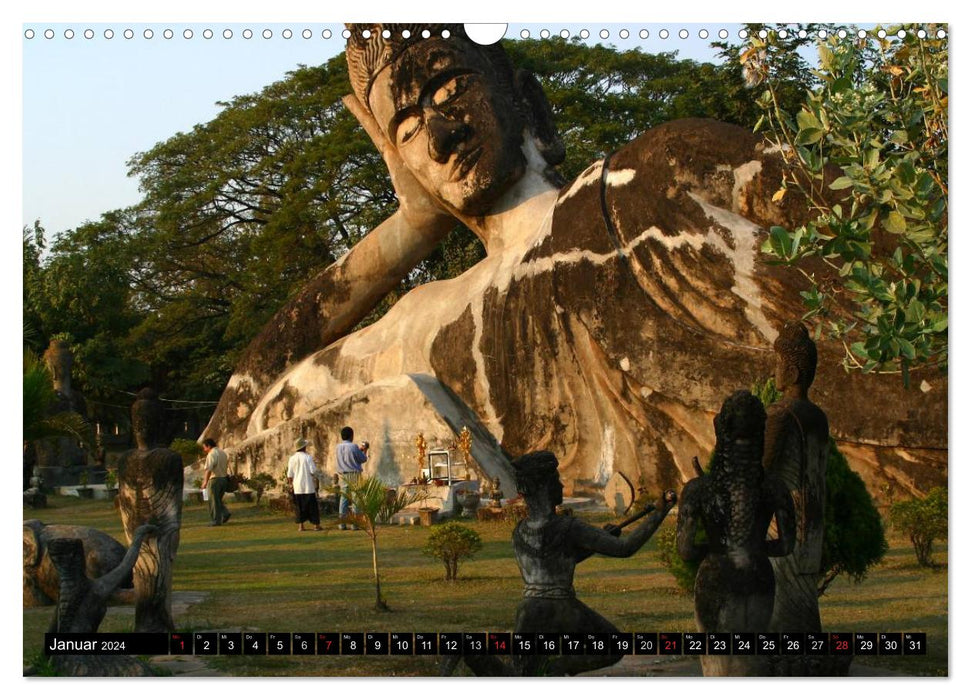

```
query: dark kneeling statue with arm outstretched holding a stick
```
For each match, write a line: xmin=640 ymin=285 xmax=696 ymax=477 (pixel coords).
xmin=512 ymin=452 xmax=677 ymax=676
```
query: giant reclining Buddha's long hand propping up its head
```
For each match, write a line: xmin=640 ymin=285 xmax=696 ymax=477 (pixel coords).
xmin=344 ymin=95 xmax=457 ymax=229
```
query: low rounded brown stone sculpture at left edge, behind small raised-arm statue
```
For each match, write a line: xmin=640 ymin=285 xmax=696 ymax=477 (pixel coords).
xmin=24 ymin=520 xmax=132 ymax=608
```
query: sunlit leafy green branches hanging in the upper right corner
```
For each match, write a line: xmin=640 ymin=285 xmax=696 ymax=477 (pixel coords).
xmin=743 ymin=26 xmax=948 ymax=383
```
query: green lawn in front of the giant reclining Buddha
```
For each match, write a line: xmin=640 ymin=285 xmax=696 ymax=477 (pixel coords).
xmin=24 ymin=497 xmax=948 ymax=676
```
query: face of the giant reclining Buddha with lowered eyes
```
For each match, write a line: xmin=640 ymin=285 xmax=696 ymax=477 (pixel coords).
xmin=368 ymin=39 xmax=526 ymax=216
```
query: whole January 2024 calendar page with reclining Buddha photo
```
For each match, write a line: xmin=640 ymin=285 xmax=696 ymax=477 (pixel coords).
xmin=19 ymin=7 xmax=950 ymax=692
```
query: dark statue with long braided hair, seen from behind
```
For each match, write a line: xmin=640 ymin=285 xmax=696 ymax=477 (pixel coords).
xmin=677 ymin=391 xmax=795 ymax=676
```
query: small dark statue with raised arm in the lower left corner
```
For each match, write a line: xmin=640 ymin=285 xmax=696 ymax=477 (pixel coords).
xmin=47 ymin=525 xmax=156 ymax=676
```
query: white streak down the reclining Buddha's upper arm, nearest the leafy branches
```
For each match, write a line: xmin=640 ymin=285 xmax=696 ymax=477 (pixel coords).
xmin=688 ymin=192 xmax=779 ymax=343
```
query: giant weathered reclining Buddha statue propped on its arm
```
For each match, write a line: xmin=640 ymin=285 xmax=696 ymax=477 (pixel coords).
xmin=204 ymin=25 xmax=947 ymax=500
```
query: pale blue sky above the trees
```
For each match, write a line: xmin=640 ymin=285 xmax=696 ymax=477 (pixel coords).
xmin=21 ymin=22 xmax=752 ymax=234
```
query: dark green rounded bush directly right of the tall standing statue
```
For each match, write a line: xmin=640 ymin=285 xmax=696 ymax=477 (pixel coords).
xmin=819 ymin=438 xmax=887 ymax=595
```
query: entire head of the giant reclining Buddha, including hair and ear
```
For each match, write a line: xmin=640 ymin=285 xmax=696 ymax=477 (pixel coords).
xmin=347 ymin=24 xmax=564 ymax=216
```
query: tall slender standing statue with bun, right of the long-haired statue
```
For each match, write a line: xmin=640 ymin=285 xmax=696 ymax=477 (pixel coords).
xmin=762 ymin=323 xmax=829 ymax=675
